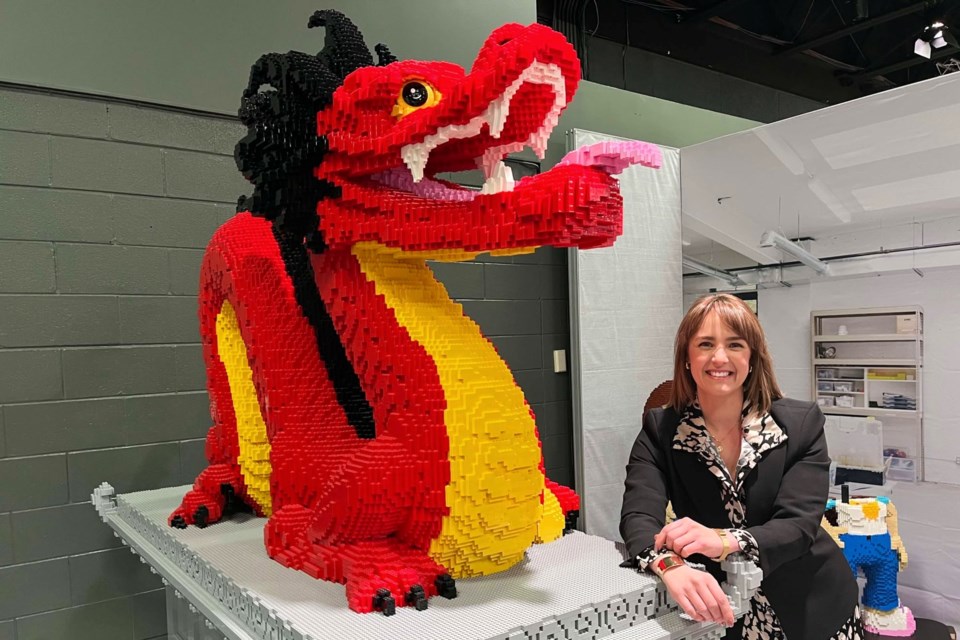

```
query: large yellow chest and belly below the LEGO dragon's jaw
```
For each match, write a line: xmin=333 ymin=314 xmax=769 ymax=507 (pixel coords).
xmin=353 ymin=244 xmax=563 ymax=577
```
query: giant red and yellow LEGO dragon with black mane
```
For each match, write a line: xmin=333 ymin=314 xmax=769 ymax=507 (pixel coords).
xmin=169 ymin=6 xmax=660 ymax=614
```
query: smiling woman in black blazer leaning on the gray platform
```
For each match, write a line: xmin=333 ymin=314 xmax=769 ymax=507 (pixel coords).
xmin=620 ymin=294 xmax=862 ymax=640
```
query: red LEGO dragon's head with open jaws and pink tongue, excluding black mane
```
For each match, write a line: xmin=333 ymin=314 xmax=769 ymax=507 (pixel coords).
xmin=316 ymin=25 xmax=659 ymax=256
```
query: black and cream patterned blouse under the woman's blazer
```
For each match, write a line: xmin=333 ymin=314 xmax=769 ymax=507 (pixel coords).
xmin=638 ymin=403 xmax=863 ymax=640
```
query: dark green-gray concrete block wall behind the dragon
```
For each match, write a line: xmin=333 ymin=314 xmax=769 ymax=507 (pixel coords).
xmin=0 ymin=88 xmax=573 ymax=640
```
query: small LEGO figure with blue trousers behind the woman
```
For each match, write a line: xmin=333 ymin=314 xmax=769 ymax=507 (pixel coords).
xmin=824 ymin=485 xmax=917 ymax=637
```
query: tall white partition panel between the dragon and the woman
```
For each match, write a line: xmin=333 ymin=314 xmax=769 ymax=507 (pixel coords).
xmin=567 ymin=129 xmax=683 ymax=540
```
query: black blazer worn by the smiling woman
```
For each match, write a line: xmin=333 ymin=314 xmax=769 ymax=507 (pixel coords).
xmin=620 ymin=398 xmax=859 ymax=640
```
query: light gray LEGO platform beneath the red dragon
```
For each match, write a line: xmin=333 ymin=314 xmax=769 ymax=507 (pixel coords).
xmin=94 ymin=485 xmax=749 ymax=640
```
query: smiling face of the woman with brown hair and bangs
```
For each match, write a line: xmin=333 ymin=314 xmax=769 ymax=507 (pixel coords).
xmin=687 ymin=311 xmax=750 ymax=398
